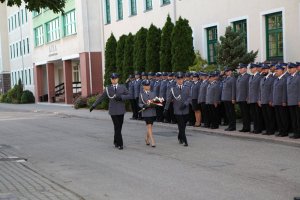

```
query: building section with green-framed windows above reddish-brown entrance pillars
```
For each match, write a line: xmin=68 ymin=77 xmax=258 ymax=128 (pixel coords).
xmin=30 ymin=0 xmax=103 ymax=104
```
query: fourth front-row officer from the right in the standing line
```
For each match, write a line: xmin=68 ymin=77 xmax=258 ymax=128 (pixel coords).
xmin=248 ymin=63 xmax=263 ymax=134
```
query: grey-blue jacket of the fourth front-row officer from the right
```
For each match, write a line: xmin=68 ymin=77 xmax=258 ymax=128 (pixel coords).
xmin=248 ymin=73 xmax=262 ymax=103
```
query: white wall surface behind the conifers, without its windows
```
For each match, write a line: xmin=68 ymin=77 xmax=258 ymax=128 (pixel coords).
xmin=103 ymin=0 xmax=300 ymax=62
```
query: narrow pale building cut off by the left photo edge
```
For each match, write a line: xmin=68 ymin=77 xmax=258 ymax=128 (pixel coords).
xmin=0 ymin=4 xmax=10 ymax=94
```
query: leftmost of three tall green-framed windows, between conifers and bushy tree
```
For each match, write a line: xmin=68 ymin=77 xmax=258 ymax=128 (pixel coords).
xmin=206 ymin=26 xmax=218 ymax=64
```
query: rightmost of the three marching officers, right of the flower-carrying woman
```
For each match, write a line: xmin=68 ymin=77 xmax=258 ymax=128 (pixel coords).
xmin=164 ymin=72 xmax=191 ymax=146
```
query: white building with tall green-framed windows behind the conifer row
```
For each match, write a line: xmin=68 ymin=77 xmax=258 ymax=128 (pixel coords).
xmin=103 ymin=0 xmax=300 ymax=63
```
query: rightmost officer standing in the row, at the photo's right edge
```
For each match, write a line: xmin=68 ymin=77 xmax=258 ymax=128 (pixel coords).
xmin=287 ymin=63 xmax=300 ymax=138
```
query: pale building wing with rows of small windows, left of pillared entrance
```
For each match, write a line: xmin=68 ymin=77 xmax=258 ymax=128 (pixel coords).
xmin=5 ymin=5 xmax=34 ymax=92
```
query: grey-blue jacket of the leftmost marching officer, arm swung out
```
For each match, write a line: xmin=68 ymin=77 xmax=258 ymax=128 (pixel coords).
xmin=93 ymin=84 xmax=130 ymax=115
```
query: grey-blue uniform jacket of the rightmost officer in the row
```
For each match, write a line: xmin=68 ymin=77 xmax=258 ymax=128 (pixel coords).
xmin=287 ymin=74 xmax=300 ymax=106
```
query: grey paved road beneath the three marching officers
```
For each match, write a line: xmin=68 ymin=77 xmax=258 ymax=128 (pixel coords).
xmin=0 ymin=107 xmax=300 ymax=200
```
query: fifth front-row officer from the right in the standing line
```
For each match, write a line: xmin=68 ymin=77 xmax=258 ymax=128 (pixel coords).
xmin=236 ymin=63 xmax=251 ymax=132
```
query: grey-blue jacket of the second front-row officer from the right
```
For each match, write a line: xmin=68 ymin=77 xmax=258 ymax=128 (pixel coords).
xmin=272 ymin=76 xmax=287 ymax=106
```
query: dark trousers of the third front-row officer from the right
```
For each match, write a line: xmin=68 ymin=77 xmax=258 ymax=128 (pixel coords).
xmin=261 ymin=104 xmax=276 ymax=134
